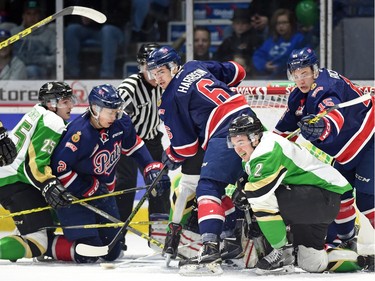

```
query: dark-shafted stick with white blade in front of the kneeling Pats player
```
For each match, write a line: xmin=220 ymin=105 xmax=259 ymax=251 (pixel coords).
xmin=76 ymin=165 xmax=167 ymax=257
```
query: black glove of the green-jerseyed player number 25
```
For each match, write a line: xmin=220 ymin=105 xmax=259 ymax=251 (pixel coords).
xmin=42 ymin=178 xmax=73 ymax=209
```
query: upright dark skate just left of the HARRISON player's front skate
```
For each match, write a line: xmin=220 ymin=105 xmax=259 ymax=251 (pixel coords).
xmin=162 ymin=222 xmax=182 ymax=267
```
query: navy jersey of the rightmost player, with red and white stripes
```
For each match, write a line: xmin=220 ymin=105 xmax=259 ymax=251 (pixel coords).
xmin=275 ymin=69 xmax=375 ymax=164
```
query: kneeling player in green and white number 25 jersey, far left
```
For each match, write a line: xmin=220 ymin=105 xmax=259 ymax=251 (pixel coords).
xmin=0 ymin=82 xmax=75 ymax=261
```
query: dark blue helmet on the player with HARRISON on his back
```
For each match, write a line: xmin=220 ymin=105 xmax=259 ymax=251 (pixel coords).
xmin=147 ymin=46 xmax=181 ymax=70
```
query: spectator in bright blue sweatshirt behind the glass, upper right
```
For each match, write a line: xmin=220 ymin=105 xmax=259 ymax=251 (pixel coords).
xmin=253 ymin=9 xmax=304 ymax=79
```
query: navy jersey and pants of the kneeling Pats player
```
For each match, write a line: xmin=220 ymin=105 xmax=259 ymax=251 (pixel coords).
xmin=51 ymin=112 xmax=153 ymax=260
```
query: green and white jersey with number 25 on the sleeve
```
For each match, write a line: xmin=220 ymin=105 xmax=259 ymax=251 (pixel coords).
xmin=0 ymin=105 xmax=65 ymax=189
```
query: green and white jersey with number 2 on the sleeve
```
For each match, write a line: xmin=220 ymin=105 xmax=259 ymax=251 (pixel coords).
xmin=242 ymin=132 xmax=352 ymax=203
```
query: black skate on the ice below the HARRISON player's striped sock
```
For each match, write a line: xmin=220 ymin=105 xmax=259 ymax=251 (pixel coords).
xmin=179 ymin=241 xmax=223 ymax=276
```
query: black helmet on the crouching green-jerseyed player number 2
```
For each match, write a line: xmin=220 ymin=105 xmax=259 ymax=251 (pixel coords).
xmin=227 ymin=115 xmax=264 ymax=148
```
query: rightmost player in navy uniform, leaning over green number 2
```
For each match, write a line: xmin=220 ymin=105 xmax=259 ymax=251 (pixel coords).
xmin=275 ymin=48 xmax=375 ymax=248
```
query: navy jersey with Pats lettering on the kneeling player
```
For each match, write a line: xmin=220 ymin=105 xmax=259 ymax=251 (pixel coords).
xmin=51 ymin=112 xmax=153 ymax=197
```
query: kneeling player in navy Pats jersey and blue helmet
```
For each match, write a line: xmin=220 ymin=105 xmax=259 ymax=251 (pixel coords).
xmin=47 ymin=84 xmax=170 ymax=263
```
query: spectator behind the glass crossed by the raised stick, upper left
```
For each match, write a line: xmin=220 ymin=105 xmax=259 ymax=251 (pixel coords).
xmin=11 ymin=0 xmax=56 ymax=79
